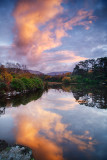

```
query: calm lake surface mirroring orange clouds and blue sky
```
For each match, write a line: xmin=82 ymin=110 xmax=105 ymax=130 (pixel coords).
xmin=0 ymin=86 xmax=107 ymax=160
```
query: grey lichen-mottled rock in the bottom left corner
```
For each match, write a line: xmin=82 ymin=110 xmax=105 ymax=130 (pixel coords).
xmin=0 ymin=140 xmax=34 ymax=160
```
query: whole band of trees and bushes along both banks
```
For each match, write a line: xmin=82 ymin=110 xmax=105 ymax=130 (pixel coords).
xmin=0 ymin=57 xmax=107 ymax=94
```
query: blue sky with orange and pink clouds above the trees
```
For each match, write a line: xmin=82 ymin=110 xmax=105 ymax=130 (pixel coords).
xmin=0 ymin=0 xmax=107 ymax=73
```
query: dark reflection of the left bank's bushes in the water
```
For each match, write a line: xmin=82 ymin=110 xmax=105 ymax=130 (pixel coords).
xmin=0 ymin=90 xmax=43 ymax=107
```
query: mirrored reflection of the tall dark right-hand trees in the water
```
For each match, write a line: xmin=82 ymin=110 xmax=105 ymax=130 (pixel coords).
xmin=72 ymin=87 xmax=107 ymax=109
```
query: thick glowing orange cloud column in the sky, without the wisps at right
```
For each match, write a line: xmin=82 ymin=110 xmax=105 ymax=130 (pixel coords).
xmin=14 ymin=0 xmax=64 ymax=59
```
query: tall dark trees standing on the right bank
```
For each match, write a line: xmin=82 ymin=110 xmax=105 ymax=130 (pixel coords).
xmin=72 ymin=57 xmax=107 ymax=83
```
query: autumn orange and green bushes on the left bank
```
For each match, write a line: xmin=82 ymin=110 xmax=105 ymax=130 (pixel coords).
xmin=0 ymin=65 xmax=43 ymax=94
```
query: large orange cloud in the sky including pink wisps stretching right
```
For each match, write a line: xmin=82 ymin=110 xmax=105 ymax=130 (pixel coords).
xmin=13 ymin=0 xmax=94 ymax=66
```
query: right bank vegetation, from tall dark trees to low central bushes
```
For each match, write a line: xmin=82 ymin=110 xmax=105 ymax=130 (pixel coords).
xmin=44 ymin=57 xmax=107 ymax=84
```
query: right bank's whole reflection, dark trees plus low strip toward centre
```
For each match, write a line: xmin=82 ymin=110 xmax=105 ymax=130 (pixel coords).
xmin=49 ymin=84 xmax=107 ymax=109
